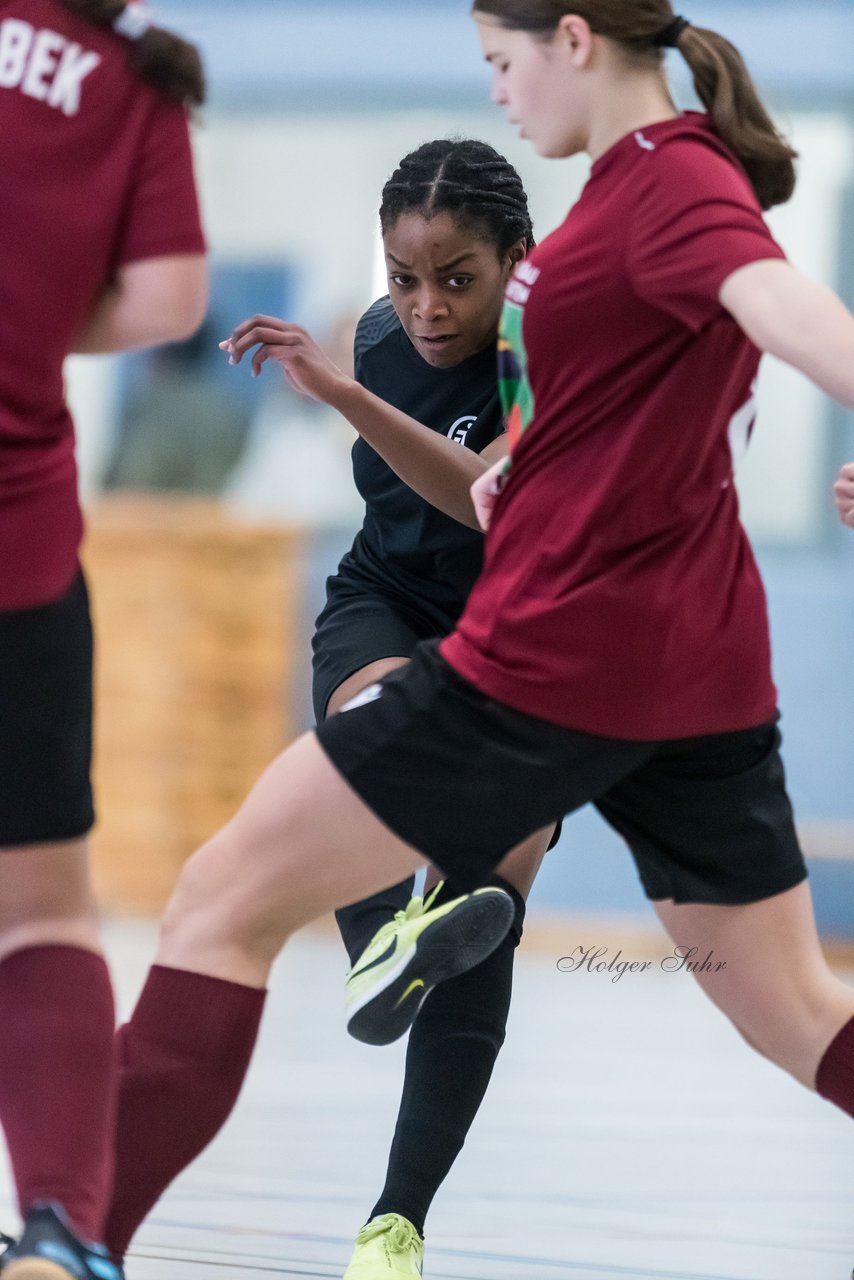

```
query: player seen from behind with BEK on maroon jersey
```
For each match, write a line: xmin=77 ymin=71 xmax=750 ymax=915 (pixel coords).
xmin=0 ymin=0 xmax=206 ymax=1280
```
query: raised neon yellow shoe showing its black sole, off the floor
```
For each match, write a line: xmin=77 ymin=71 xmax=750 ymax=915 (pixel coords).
xmin=346 ymin=888 xmax=515 ymax=1044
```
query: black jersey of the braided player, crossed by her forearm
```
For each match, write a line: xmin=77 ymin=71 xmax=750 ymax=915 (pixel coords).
xmin=338 ymin=298 xmax=504 ymax=621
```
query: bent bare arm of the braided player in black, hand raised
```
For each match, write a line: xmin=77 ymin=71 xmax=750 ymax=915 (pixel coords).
xmin=220 ymin=316 xmax=506 ymax=529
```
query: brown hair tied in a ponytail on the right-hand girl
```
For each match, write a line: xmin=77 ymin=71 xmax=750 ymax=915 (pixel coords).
xmin=474 ymin=0 xmax=798 ymax=209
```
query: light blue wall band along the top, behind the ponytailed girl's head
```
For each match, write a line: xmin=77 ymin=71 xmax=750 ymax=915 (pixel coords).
xmin=157 ymin=0 xmax=854 ymax=109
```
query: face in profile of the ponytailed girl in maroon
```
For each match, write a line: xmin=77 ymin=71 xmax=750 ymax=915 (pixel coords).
xmin=475 ymin=12 xmax=589 ymax=159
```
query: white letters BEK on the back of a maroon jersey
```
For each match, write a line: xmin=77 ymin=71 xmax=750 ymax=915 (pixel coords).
xmin=0 ymin=18 xmax=101 ymax=115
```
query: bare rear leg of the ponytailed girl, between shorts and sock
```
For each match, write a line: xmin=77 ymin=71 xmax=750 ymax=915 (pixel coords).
xmin=653 ymin=882 xmax=854 ymax=1089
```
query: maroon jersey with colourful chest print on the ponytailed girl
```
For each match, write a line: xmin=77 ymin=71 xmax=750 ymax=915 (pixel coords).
xmin=442 ymin=122 xmax=784 ymax=740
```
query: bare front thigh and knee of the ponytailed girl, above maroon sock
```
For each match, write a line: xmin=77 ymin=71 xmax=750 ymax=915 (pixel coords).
xmin=159 ymin=733 xmax=425 ymax=986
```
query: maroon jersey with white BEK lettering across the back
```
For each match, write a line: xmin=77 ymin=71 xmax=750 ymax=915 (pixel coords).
xmin=0 ymin=0 xmax=205 ymax=609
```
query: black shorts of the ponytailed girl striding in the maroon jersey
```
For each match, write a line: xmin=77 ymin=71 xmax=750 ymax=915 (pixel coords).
xmin=318 ymin=641 xmax=807 ymax=904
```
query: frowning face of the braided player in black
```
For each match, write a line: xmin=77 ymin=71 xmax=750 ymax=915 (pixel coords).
xmin=383 ymin=214 xmax=524 ymax=369
